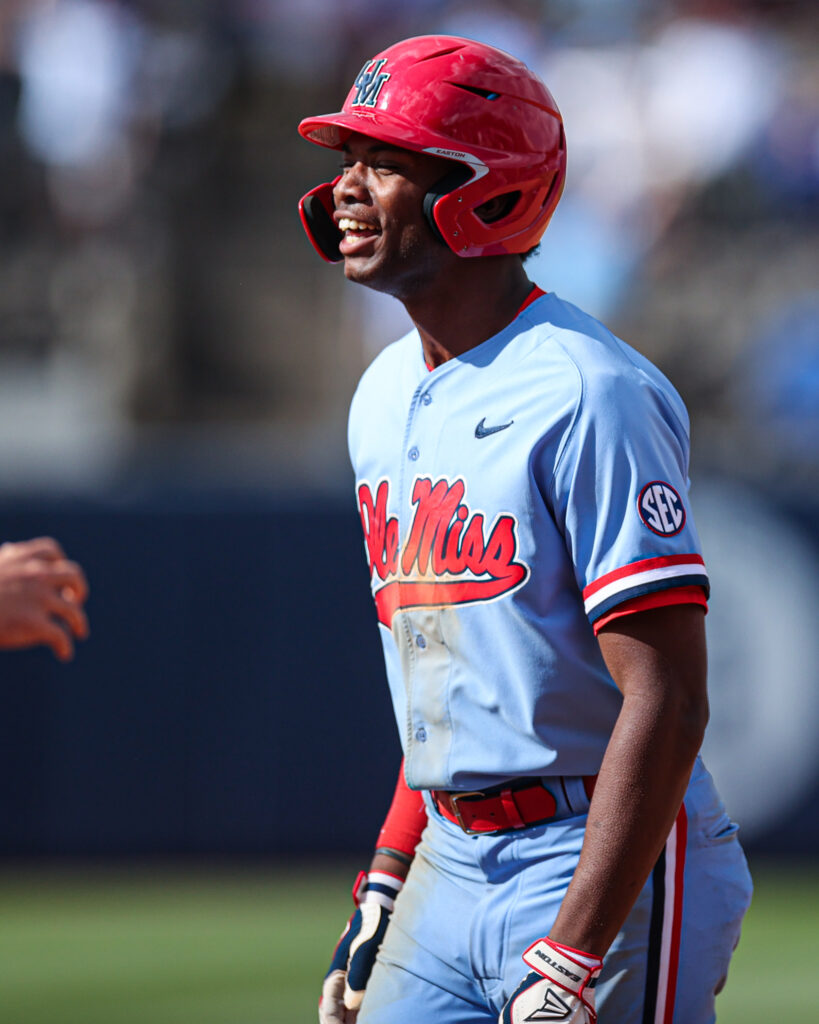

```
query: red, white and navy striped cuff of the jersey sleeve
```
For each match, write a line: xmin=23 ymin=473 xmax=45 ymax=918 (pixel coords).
xmin=583 ymin=554 xmax=708 ymax=623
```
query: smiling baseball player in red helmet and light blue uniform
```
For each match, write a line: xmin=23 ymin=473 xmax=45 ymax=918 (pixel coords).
xmin=299 ymin=37 xmax=750 ymax=1024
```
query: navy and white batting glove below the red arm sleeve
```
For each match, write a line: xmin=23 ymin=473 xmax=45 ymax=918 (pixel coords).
xmin=318 ymin=871 xmax=403 ymax=1024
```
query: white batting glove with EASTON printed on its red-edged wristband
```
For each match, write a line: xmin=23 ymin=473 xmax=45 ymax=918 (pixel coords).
xmin=498 ymin=939 xmax=603 ymax=1024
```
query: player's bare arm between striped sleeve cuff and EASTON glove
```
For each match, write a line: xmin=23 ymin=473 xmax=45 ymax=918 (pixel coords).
xmin=550 ymin=604 xmax=708 ymax=956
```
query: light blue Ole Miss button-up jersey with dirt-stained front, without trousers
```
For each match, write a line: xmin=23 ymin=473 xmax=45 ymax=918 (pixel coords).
xmin=349 ymin=295 xmax=707 ymax=790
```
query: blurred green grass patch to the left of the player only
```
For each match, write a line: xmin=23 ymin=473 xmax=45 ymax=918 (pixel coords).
xmin=0 ymin=870 xmax=354 ymax=1024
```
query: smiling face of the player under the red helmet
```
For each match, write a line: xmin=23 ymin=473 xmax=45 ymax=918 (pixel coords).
xmin=333 ymin=134 xmax=458 ymax=297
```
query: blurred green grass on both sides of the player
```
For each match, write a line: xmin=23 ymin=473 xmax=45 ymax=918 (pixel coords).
xmin=0 ymin=867 xmax=819 ymax=1024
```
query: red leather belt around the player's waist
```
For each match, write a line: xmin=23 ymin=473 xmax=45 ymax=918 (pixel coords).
xmin=431 ymin=775 xmax=597 ymax=835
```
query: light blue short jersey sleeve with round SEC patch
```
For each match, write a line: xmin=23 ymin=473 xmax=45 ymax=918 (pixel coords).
xmin=552 ymin=368 xmax=708 ymax=624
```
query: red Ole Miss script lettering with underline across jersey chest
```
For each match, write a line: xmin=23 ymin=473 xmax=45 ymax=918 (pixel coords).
xmin=358 ymin=477 xmax=529 ymax=627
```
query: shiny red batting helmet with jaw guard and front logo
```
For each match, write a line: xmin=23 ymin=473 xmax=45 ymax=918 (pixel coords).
xmin=299 ymin=36 xmax=566 ymax=262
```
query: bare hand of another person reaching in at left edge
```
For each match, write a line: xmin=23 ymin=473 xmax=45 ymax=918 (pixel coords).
xmin=0 ymin=537 xmax=88 ymax=662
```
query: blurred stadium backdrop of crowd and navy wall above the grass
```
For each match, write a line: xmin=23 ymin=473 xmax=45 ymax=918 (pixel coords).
xmin=0 ymin=0 xmax=819 ymax=859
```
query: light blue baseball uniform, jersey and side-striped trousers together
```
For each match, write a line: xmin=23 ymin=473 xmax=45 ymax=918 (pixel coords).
xmin=349 ymin=295 xmax=750 ymax=1024
